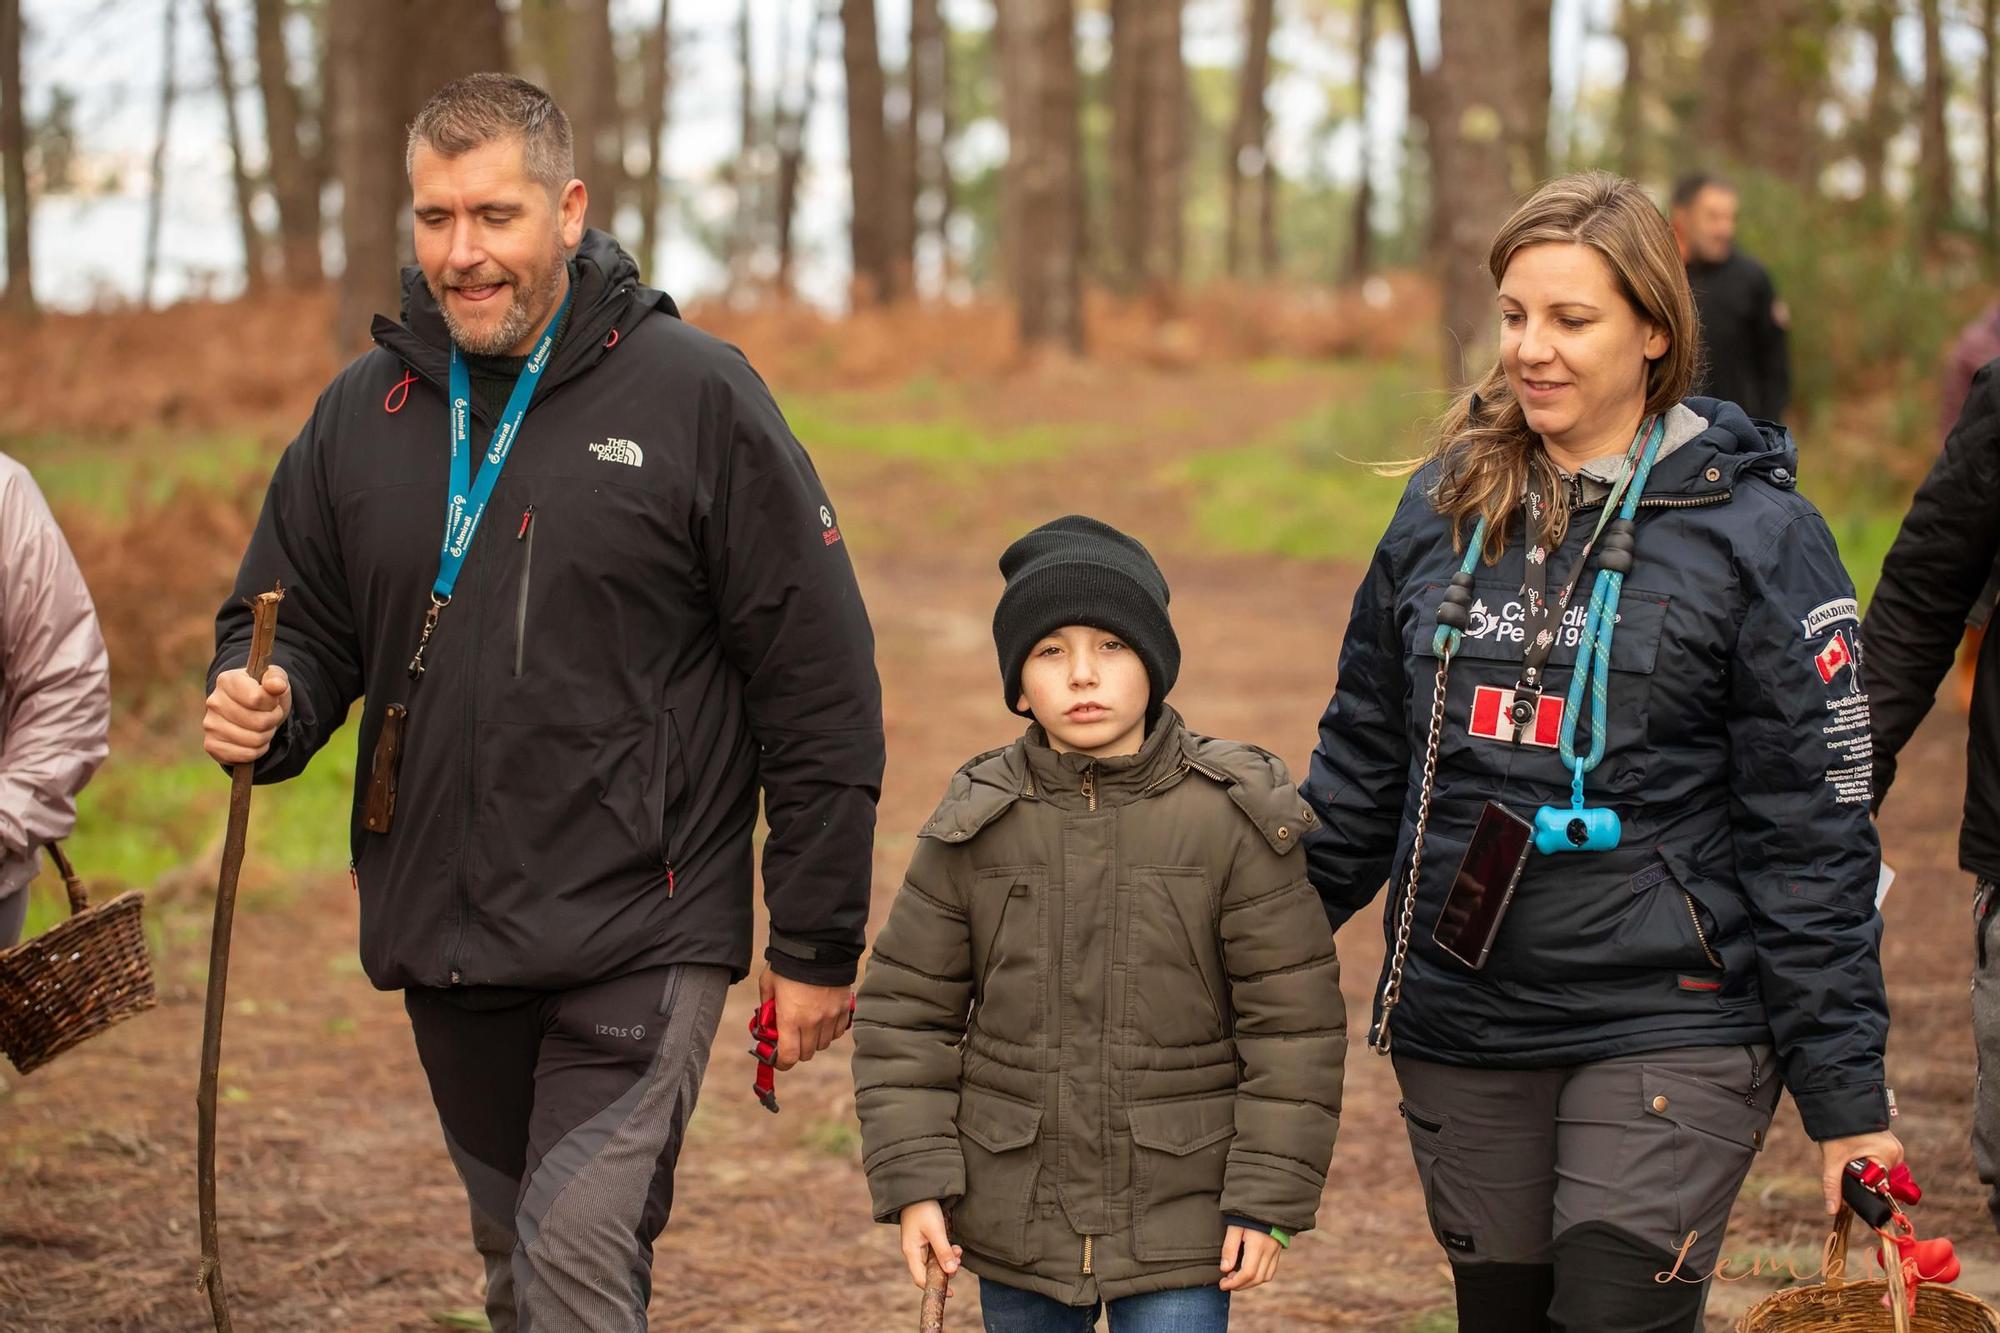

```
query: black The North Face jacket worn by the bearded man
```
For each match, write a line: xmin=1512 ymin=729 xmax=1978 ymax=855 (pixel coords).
xmin=210 ymin=232 xmax=884 ymax=989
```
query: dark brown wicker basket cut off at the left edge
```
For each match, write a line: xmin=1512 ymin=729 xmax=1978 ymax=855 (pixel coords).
xmin=0 ymin=843 xmax=158 ymax=1073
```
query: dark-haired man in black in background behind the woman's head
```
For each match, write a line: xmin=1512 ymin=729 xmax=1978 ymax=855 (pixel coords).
xmin=1674 ymin=174 xmax=1792 ymax=420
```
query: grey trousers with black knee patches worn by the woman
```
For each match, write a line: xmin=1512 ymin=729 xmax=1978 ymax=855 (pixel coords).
xmin=1394 ymin=1045 xmax=1782 ymax=1333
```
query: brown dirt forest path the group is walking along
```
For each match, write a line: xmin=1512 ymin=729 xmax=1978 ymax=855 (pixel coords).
xmin=0 ymin=364 xmax=2000 ymax=1333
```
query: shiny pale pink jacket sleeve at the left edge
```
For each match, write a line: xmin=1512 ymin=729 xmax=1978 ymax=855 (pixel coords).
xmin=0 ymin=454 xmax=110 ymax=895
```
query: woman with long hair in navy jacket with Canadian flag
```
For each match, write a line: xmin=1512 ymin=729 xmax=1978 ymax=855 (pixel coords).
xmin=1304 ymin=172 xmax=1902 ymax=1333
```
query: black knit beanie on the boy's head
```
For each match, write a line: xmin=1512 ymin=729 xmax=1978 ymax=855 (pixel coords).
xmin=994 ymin=514 xmax=1180 ymax=715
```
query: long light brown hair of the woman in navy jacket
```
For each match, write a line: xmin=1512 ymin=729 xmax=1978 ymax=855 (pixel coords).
xmin=1422 ymin=172 xmax=1700 ymax=562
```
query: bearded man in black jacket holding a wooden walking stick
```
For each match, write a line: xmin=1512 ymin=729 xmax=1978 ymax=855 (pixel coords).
xmin=206 ymin=74 xmax=882 ymax=1333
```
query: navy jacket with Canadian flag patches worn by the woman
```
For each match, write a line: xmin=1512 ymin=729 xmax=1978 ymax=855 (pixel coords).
xmin=1302 ymin=398 xmax=1888 ymax=1139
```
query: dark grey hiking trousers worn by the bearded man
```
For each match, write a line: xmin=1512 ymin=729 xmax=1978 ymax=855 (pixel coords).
xmin=404 ymin=963 xmax=730 ymax=1333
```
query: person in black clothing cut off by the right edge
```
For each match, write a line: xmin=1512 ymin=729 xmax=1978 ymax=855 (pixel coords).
xmin=1862 ymin=362 xmax=2000 ymax=1225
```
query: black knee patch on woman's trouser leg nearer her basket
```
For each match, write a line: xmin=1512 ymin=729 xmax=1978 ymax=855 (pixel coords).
xmin=1548 ymin=1223 xmax=1708 ymax=1333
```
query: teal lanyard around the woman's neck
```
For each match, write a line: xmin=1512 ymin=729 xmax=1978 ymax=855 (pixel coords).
xmin=1432 ymin=416 xmax=1666 ymax=805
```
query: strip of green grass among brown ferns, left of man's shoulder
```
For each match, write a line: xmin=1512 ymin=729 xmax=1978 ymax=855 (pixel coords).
xmin=0 ymin=434 xmax=270 ymax=520
